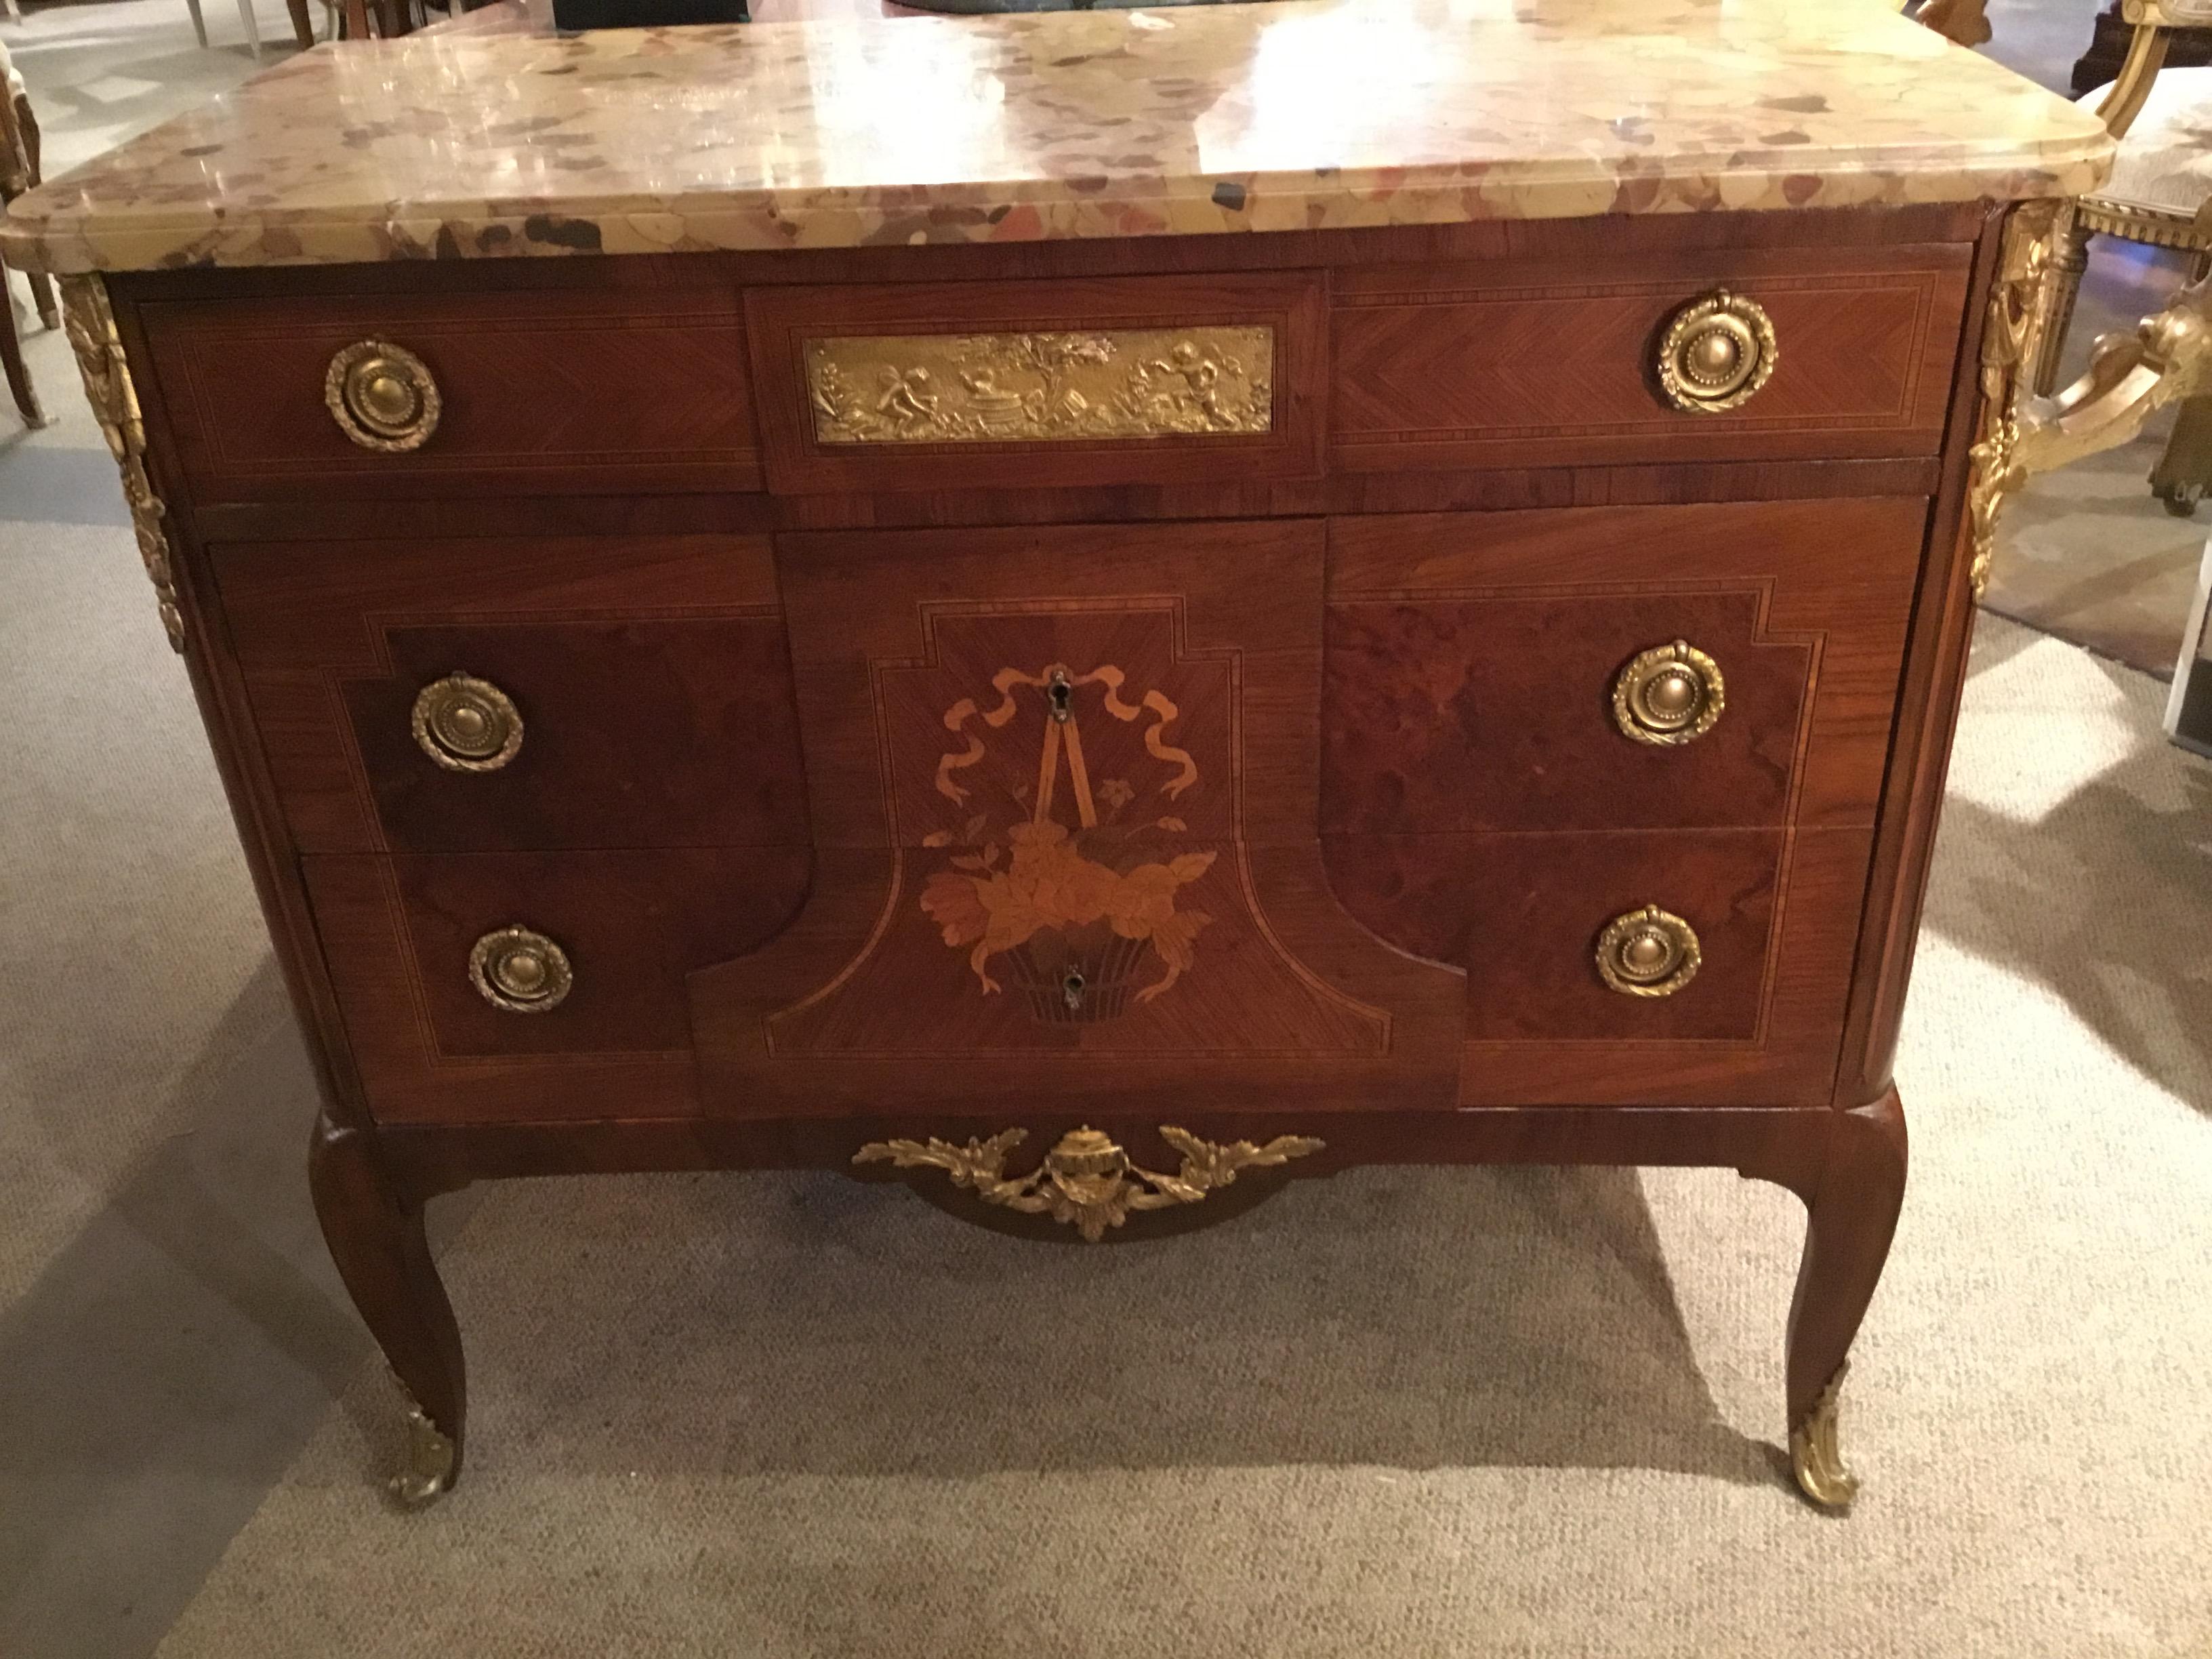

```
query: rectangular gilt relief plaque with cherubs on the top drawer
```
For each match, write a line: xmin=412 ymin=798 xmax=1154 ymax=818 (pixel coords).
xmin=805 ymin=325 xmax=1274 ymax=445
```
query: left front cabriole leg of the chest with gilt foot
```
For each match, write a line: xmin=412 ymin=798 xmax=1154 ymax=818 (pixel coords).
xmin=308 ymin=1113 xmax=469 ymax=1509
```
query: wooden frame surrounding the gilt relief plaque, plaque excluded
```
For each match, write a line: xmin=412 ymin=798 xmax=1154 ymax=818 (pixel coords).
xmin=745 ymin=272 xmax=1327 ymax=493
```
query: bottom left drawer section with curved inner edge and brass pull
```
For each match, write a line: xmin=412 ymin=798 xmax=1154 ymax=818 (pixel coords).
xmin=301 ymin=847 xmax=812 ymax=1124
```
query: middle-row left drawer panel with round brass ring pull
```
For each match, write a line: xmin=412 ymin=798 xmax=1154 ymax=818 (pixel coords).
xmin=215 ymin=537 xmax=807 ymax=854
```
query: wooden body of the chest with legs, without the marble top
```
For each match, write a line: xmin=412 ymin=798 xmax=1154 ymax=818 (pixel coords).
xmin=64 ymin=208 xmax=2004 ymax=1502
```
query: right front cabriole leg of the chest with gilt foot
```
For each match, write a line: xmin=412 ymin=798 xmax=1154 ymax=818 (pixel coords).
xmin=1790 ymin=1088 xmax=1904 ymax=1509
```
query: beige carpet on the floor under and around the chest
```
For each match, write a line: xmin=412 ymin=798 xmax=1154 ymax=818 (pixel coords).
xmin=0 ymin=592 xmax=2212 ymax=1659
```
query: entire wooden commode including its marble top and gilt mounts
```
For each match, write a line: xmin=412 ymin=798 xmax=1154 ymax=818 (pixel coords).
xmin=7 ymin=0 xmax=2108 ymax=1504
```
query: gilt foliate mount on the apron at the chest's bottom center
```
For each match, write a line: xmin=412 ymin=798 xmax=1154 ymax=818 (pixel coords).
xmin=852 ymin=1126 xmax=1321 ymax=1243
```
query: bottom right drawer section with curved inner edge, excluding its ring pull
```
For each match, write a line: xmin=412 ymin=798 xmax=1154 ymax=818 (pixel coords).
xmin=1325 ymin=830 xmax=1874 ymax=1106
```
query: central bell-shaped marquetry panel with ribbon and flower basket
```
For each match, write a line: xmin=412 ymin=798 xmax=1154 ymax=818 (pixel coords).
xmin=693 ymin=520 xmax=1460 ymax=1115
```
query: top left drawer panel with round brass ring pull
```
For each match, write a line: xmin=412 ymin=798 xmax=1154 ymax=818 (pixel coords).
xmin=142 ymin=285 xmax=761 ymax=502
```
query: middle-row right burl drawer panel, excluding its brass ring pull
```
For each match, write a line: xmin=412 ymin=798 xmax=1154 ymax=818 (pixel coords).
xmin=1321 ymin=500 xmax=1927 ymax=836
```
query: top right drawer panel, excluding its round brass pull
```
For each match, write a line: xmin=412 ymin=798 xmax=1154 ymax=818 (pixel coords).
xmin=1330 ymin=243 xmax=1973 ymax=469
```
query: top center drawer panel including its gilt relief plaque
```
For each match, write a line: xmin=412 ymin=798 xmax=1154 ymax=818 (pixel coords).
xmin=745 ymin=272 xmax=1325 ymax=493
